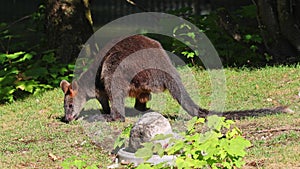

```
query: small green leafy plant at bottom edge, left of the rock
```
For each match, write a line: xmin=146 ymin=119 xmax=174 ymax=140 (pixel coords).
xmin=61 ymin=156 xmax=98 ymax=169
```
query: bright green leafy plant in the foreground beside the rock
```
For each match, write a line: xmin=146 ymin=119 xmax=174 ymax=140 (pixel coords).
xmin=135 ymin=115 xmax=251 ymax=169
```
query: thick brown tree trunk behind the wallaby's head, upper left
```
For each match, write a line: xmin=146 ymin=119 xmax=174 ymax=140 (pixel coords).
xmin=45 ymin=0 xmax=93 ymax=63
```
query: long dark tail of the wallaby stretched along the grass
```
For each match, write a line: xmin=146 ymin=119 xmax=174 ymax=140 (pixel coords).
xmin=165 ymin=77 xmax=293 ymax=119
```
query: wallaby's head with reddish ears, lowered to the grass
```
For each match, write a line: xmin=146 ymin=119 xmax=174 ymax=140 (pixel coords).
xmin=60 ymin=80 xmax=86 ymax=122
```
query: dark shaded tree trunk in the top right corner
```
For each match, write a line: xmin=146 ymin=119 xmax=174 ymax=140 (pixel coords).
xmin=253 ymin=0 xmax=300 ymax=61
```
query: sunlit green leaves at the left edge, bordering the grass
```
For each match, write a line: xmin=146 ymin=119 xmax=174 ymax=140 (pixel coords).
xmin=0 ymin=51 xmax=72 ymax=102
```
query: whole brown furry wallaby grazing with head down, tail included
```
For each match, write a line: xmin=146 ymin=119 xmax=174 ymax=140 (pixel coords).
xmin=61 ymin=35 xmax=286 ymax=121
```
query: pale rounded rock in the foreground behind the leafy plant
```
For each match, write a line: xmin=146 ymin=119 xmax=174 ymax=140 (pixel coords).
xmin=126 ymin=112 xmax=173 ymax=152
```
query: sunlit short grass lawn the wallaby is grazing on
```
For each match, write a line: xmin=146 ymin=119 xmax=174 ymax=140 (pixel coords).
xmin=0 ymin=66 xmax=300 ymax=168
